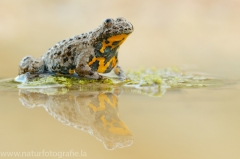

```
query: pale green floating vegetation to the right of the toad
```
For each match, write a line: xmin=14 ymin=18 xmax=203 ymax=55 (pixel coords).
xmin=125 ymin=67 xmax=222 ymax=88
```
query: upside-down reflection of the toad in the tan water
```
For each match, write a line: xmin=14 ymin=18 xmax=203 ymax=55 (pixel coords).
xmin=19 ymin=88 xmax=133 ymax=149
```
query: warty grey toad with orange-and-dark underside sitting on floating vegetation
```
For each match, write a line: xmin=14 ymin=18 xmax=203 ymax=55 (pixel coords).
xmin=19 ymin=18 xmax=133 ymax=79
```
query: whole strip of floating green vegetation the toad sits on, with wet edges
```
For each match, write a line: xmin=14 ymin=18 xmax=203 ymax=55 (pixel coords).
xmin=0 ymin=67 xmax=223 ymax=97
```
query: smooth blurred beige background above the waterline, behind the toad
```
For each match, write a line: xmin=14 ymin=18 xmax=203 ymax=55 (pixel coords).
xmin=0 ymin=0 xmax=240 ymax=78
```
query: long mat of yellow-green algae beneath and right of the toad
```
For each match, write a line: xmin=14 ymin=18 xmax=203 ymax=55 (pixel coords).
xmin=18 ymin=68 xmax=220 ymax=88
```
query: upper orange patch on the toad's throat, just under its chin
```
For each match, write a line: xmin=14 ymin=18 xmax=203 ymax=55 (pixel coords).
xmin=100 ymin=34 xmax=128 ymax=53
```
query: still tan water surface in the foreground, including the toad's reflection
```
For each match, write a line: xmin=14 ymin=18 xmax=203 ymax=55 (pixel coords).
xmin=0 ymin=77 xmax=240 ymax=159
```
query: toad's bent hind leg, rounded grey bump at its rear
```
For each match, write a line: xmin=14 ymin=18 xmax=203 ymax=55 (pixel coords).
xmin=18 ymin=56 xmax=44 ymax=75
